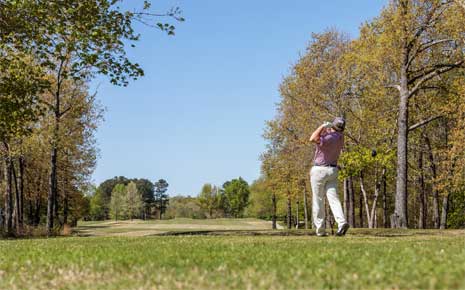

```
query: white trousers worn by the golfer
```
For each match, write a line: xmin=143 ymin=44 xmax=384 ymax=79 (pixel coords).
xmin=310 ymin=166 xmax=346 ymax=233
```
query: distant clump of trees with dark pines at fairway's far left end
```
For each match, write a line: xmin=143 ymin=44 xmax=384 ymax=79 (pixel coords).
xmin=84 ymin=176 xmax=169 ymax=220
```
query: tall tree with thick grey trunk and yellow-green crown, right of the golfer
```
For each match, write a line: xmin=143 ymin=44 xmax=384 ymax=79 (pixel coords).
xmin=381 ymin=0 xmax=465 ymax=228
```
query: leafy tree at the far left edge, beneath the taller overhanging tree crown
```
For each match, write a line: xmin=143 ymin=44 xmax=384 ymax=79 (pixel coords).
xmin=0 ymin=52 xmax=46 ymax=235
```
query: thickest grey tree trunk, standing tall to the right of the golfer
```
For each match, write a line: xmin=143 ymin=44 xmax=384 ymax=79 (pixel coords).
xmin=392 ymin=7 xmax=410 ymax=228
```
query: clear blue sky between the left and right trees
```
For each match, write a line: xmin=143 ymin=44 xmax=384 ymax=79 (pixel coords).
xmin=92 ymin=0 xmax=388 ymax=195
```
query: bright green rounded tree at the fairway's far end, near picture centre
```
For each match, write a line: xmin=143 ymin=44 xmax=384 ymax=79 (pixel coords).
xmin=223 ymin=177 xmax=250 ymax=218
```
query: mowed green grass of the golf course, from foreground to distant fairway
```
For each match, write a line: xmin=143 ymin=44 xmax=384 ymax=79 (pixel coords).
xmin=0 ymin=220 xmax=465 ymax=289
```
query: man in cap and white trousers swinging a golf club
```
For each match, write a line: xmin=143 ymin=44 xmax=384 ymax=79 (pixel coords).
xmin=310 ymin=117 xmax=349 ymax=237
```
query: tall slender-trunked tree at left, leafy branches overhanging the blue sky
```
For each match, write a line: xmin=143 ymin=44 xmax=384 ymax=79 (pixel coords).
xmin=0 ymin=0 xmax=183 ymax=235
